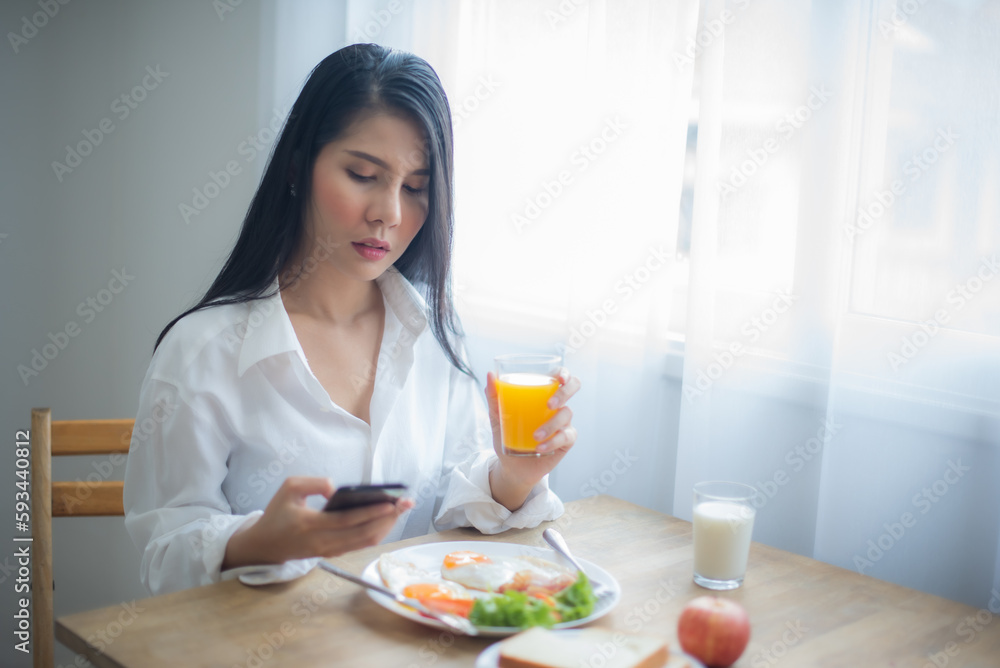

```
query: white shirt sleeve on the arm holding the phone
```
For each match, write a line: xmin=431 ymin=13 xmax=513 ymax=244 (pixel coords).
xmin=124 ymin=378 xmax=315 ymax=595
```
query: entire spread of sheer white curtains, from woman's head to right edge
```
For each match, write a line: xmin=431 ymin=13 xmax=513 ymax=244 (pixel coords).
xmin=264 ymin=0 xmax=1000 ymax=606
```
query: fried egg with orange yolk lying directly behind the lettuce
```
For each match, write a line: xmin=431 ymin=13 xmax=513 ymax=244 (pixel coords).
xmin=441 ymin=550 xmax=576 ymax=594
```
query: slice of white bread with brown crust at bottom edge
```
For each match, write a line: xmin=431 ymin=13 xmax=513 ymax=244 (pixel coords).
xmin=499 ymin=628 xmax=687 ymax=668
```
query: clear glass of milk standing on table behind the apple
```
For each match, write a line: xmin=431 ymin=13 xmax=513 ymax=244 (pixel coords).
xmin=692 ymin=482 xmax=757 ymax=590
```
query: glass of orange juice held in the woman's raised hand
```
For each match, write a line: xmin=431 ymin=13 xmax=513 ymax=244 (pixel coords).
xmin=495 ymin=355 xmax=562 ymax=457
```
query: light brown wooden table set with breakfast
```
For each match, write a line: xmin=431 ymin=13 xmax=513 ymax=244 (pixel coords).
xmin=56 ymin=496 xmax=1000 ymax=668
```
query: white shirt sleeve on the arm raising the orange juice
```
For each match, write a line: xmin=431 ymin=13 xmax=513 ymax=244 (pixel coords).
xmin=434 ymin=360 xmax=563 ymax=534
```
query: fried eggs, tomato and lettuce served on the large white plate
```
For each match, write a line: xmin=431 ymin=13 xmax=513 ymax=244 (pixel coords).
xmin=378 ymin=551 xmax=596 ymax=628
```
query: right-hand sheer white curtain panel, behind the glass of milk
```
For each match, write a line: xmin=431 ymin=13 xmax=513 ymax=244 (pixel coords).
xmin=673 ymin=0 xmax=1000 ymax=606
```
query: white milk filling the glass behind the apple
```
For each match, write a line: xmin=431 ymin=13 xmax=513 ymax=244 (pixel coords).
xmin=693 ymin=501 xmax=756 ymax=580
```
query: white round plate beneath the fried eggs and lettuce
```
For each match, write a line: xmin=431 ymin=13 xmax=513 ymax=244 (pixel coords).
xmin=361 ymin=540 xmax=622 ymax=637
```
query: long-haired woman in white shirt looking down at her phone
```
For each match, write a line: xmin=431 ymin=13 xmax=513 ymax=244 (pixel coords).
xmin=125 ymin=44 xmax=579 ymax=593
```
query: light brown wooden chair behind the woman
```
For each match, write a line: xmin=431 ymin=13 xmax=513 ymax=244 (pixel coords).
xmin=30 ymin=408 xmax=135 ymax=668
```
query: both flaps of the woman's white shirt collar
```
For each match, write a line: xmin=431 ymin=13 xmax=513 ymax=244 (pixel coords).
xmin=237 ymin=267 xmax=427 ymax=377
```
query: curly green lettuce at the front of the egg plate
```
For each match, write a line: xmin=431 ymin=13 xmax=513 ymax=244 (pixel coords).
xmin=469 ymin=572 xmax=597 ymax=629
